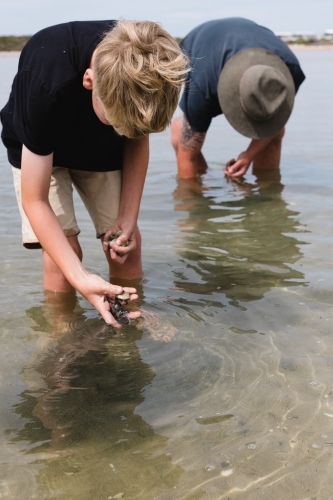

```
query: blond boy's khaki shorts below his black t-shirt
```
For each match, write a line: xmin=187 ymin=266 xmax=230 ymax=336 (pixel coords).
xmin=12 ymin=167 xmax=121 ymax=248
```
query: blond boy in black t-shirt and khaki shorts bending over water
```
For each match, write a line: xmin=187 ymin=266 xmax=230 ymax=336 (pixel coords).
xmin=1 ymin=20 xmax=185 ymax=326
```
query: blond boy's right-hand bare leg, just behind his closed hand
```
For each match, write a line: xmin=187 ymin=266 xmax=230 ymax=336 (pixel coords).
xmin=101 ymin=229 xmax=143 ymax=280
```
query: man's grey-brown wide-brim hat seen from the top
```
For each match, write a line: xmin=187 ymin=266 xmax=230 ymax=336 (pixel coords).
xmin=217 ymin=48 xmax=295 ymax=139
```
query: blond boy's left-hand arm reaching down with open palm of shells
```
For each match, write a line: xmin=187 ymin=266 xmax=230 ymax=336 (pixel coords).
xmin=21 ymin=146 xmax=139 ymax=326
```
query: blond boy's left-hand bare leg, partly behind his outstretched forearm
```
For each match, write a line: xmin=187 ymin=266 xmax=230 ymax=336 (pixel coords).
xmin=43 ymin=235 xmax=82 ymax=292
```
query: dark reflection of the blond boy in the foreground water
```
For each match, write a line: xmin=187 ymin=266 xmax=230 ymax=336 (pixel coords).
xmin=10 ymin=294 xmax=182 ymax=500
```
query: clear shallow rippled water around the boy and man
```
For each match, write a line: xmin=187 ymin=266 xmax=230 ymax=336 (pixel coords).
xmin=0 ymin=51 xmax=333 ymax=500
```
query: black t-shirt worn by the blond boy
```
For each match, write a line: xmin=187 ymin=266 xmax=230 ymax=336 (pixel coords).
xmin=1 ymin=21 xmax=124 ymax=172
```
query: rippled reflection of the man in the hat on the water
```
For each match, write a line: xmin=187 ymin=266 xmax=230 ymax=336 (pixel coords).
xmin=174 ymin=171 xmax=304 ymax=307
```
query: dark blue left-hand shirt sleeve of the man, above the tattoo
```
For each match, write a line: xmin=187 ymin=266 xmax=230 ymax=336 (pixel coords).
xmin=179 ymin=80 xmax=215 ymax=132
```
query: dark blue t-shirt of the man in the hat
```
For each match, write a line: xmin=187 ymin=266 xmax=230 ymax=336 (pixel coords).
xmin=179 ymin=17 xmax=305 ymax=132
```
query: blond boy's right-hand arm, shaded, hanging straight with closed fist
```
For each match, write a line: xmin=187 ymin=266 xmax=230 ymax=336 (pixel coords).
xmin=104 ymin=136 xmax=149 ymax=263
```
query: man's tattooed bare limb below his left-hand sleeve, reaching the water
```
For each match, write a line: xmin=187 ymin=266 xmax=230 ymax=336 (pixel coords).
xmin=171 ymin=115 xmax=207 ymax=179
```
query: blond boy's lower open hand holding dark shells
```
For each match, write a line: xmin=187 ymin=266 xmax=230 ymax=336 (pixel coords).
xmin=77 ymin=274 xmax=141 ymax=328
